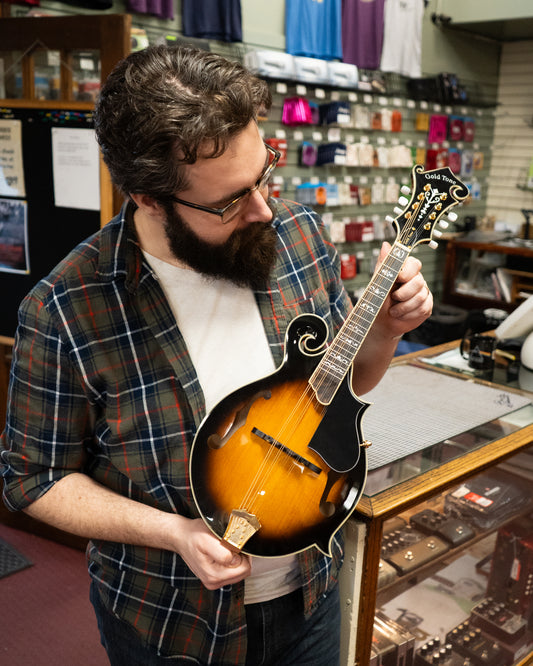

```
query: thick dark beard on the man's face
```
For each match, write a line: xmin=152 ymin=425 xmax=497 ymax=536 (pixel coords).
xmin=164 ymin=203 xmax=277 ymax=289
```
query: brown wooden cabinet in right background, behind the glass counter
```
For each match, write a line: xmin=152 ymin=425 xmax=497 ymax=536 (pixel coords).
xmin=442 ymin=240 xmax=533 ymax=311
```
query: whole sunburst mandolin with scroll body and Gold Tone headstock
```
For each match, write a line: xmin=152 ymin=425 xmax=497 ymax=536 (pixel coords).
xmin=190 ymin=166 xmax=468 ymax=557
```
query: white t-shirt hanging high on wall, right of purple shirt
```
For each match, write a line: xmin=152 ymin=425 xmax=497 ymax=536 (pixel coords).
xmin=380 ymin=0 xmax=424 ymax=79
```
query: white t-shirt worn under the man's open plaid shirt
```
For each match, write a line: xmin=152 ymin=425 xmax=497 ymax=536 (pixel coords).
xmin=144 ymin=252 xmax=301 ymax=604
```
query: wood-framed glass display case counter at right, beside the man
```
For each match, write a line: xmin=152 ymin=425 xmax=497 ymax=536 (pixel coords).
xmin=341 ymin=343 xmax=533 ymax=666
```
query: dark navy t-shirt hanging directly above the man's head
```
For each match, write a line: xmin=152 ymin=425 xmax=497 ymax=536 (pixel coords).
xmin=181 ymin=0 xmax=242 ymax=42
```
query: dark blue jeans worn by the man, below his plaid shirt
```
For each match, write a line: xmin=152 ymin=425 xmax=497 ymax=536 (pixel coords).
xmin=91 ymin=584 xmax=340 ymax=666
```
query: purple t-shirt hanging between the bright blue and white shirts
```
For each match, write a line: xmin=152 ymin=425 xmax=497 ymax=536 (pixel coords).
xmin=342 ymin=0 xmax=385 ymax=69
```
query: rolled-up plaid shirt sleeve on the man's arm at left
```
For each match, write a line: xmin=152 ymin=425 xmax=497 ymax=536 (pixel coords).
xmin=0 ymin=292 xmax=91 ymax=511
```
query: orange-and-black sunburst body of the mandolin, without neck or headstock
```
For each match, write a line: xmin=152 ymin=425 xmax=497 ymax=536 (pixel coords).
xmin=190 ymin=315 xmax=368 ymax=557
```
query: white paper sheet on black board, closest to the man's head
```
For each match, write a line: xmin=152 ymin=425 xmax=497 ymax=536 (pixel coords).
xmin=52 ymin=127 xmax=100 ymax=210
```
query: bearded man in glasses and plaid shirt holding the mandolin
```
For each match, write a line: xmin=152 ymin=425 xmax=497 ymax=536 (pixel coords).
xmin=2 ymin=46 xmax=432 ymax=666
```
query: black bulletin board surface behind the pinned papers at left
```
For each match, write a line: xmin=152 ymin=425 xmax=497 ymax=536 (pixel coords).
xmin=0 ymin=108 xmax=100 ymax=337
